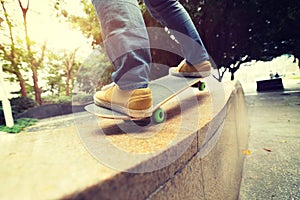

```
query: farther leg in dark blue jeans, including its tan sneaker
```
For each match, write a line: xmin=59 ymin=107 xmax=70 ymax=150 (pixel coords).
xmin=144 ymin=0 xmax=211 ymax=76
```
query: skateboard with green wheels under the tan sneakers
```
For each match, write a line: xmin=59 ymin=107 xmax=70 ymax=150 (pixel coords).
xmin=85 ymin=75 xmax=206 ymax=123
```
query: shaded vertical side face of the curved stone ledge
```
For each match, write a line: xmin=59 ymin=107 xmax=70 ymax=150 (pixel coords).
xmin=65 ymin=83 xmax=248 ymax=200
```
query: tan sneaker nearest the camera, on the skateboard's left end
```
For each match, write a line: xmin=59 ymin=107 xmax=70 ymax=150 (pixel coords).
xmin=94 ymin=83 xmax=152 ymax=118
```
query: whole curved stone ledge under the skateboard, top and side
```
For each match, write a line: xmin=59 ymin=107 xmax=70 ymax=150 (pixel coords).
xmin=0 ymin=80 xmax=248 ymax=199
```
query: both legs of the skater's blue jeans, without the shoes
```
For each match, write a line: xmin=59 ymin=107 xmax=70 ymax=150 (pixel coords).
xmin=92 ymin=0 xmax=209 ymax=90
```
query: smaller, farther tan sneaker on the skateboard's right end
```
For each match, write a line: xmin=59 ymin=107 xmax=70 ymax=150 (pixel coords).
xmin=170 ymin=60 xmax=212 ymax=78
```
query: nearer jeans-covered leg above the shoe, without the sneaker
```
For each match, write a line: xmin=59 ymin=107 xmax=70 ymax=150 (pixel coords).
xmin=92 ymin=0 xmax=151 ymax=90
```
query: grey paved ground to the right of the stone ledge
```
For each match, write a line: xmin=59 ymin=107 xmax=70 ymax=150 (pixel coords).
xmin=240 ymin=81 xmax=300 ymax=200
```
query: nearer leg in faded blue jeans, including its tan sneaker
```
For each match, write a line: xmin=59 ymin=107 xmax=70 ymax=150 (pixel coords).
xmin=92 ymin=0 xmax=152 ymax=117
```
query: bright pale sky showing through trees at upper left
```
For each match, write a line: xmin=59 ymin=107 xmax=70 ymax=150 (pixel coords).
xmin=0 ymin=0 xmax=92 ymax=96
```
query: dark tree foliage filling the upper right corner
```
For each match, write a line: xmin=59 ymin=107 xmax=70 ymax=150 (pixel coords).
xmin=182 ymin=0 xmax=300 ymax=78
